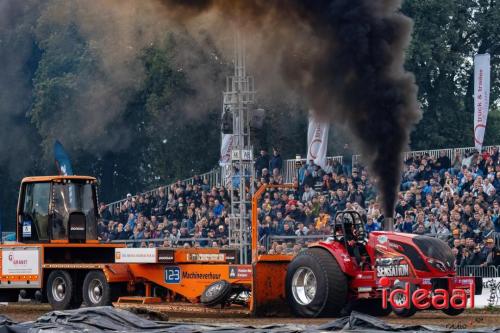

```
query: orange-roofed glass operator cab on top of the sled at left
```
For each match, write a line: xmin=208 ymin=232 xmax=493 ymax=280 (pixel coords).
xmin=17 ymin=176 xmax=98 ymax=243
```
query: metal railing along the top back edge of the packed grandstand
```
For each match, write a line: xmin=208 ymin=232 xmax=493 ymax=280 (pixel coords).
xmin=108 ymin=145 xmax=500 ymax=209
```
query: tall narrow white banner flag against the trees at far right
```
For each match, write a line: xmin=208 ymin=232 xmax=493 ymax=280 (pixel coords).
xmin=474 ymin=53 xmax=490 ymax=151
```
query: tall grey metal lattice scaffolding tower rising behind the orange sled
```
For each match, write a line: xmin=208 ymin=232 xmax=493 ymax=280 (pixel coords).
xmin=223 ymin=31 xmax=255 ymax=264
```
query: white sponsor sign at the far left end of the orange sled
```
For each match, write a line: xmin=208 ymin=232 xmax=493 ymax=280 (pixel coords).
xmin=2 ymin=248 xmax=40 ymax=275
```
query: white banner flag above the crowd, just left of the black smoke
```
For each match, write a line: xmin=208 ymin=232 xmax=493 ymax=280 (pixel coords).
xmin=307 ymin=117 xmax=330 ymax=168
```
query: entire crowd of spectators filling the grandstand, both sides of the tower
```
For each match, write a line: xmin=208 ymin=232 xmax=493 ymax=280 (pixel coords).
xmin=99 ymin=145 xmax=500 ymax=266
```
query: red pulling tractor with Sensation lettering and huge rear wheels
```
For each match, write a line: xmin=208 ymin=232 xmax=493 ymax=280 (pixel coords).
xmin=286 ymin=211 xmax=475 ymax=317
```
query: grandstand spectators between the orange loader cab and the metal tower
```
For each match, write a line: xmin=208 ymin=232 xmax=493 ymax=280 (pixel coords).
xmin=98 ymin=177 xmax=233 ymax=247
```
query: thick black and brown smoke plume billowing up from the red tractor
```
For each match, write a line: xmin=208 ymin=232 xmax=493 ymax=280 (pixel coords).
xmin=162 ymin=0 xmax=421 ymax=217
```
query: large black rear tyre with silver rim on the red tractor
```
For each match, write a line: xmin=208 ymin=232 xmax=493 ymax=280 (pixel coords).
xmin=286 ymin=248 xmax=347 ymax=317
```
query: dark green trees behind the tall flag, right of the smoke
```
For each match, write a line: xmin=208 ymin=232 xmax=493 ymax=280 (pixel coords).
xmin=403 ymin=0 xmax=500 ymax=149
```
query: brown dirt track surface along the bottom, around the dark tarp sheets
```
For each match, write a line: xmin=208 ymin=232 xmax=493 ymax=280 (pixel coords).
xmin=0 ymin=303 xmax=500 ymax=329
